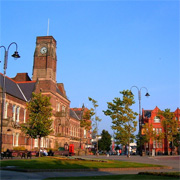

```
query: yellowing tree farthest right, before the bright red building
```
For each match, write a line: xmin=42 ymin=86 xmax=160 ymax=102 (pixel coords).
xmin=158 ymin=109 xmax=178 ymax=154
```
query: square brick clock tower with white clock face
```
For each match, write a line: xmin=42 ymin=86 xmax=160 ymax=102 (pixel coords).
xmin=32 ymin=36 xmax=57 ymax=82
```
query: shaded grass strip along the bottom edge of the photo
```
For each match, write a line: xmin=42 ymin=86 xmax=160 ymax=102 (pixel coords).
xmin=45 ymin=174 xmax=179 ymax=180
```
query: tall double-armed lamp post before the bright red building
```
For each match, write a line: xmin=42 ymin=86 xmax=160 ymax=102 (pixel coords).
xmin=130 ymin=86 xmax=150 ymax=154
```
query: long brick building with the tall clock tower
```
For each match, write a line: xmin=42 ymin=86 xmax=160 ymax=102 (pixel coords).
xmin=0 ymin=36 xmax=90 ymax=153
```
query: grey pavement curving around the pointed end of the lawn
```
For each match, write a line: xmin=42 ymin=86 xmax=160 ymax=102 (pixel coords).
xmin=0 ymin=156 xmax=180 ymax=180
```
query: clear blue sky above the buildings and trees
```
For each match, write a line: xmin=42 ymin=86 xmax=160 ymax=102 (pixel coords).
xmin=0 ymin=0 xmax=180 ymax=136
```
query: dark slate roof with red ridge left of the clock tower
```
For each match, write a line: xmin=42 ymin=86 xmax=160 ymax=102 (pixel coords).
xmin=0 ymin=73 xmax=36 ymax=101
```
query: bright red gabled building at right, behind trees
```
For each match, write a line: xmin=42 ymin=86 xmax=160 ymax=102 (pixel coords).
xmin=141 ymin=106 xmax=180 ymax=154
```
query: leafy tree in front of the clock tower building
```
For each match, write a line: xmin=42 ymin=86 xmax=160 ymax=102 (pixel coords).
xmin=22 ymin=93 xmax=52 ymax=156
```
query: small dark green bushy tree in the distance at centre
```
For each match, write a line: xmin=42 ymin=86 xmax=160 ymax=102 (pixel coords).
xmin=98 ymin=130 xmax=111 ymax=151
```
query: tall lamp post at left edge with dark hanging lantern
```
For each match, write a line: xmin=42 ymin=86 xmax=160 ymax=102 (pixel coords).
xmin=0 ymin=42 xmax=20 ymax=156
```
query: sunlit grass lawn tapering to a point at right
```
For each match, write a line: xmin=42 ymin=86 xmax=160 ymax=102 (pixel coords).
xmin=0 ymin=157 xmax=162 ymax=169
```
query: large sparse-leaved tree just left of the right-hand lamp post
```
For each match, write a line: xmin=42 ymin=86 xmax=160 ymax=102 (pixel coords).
xmin=103 ymin=90 xmax=138 ymax=157
